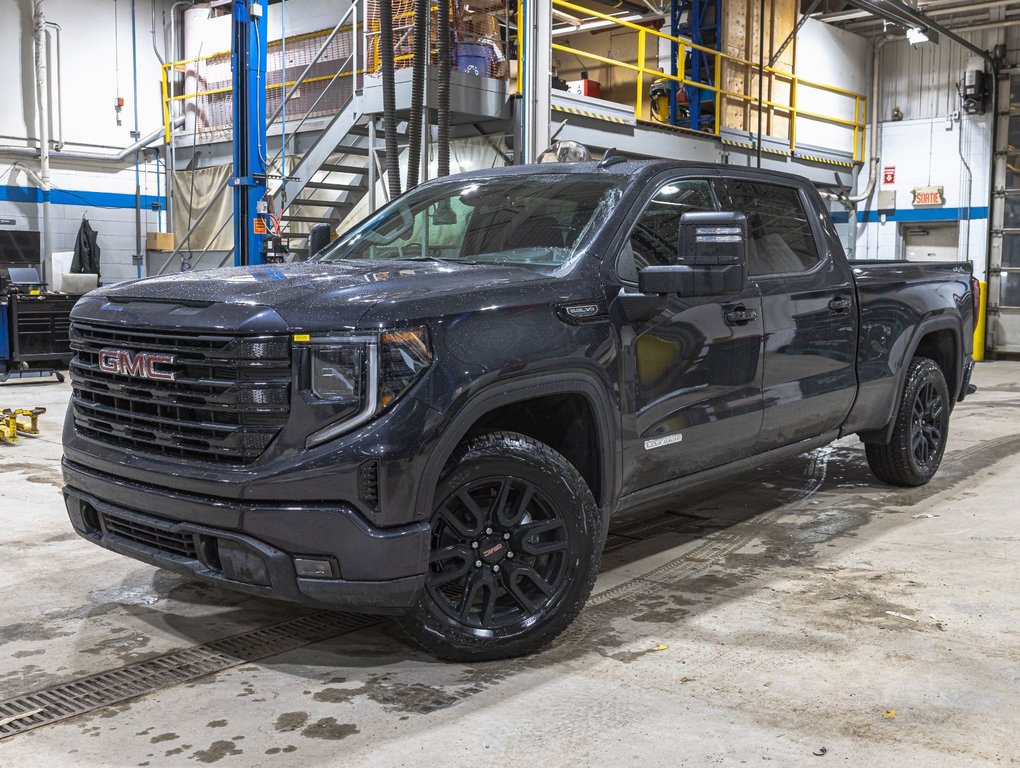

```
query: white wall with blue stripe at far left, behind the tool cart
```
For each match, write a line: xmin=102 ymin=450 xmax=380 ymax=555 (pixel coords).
xmin=0 ymin=0 xmax=170 ymax=281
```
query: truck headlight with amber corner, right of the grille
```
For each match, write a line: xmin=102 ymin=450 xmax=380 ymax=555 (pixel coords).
xmin=295 ymin=327 xmax=432 ymax=448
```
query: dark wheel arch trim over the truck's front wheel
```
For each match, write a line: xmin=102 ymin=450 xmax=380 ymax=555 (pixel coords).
xmin=414 ymin=372 xmax=619 ymax=520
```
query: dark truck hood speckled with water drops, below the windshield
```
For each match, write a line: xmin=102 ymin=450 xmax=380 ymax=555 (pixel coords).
xmin=89 ymin=261 xmax=554 ymax=330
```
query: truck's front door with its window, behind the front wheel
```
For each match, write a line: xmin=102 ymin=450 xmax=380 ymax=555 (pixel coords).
xmin=612 ymin=177 xmax=762 ymax=493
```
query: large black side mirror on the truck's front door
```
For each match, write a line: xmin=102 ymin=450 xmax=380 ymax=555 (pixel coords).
xmin=638 ymin=211 xmax=748 ymax=298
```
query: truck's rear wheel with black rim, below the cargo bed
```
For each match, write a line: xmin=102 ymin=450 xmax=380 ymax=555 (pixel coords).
xmin=865 ymin=357 xmax=950 ymax=488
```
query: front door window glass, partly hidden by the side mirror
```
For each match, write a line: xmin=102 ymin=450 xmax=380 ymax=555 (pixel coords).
xmin=619 ymin=178 xmax=719 ymax=280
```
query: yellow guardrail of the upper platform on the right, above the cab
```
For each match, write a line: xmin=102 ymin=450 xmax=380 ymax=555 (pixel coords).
xmin=546 ymin=0 xmax=868 ymax=162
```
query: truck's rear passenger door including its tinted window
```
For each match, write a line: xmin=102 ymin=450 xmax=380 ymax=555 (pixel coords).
xmin=725 ymin=177 xmax=857 ymax=451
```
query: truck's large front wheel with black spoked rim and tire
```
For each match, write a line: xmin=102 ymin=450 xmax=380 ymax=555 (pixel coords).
xmin=401 ymin=431 xmax=602 ymax=662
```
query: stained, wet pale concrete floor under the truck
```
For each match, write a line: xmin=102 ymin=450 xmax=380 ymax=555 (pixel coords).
xmin=0 ymin=363 xmax=1020 ymax=768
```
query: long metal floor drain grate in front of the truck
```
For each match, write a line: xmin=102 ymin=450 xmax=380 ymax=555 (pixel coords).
xmin=0 ymin=613 xmax=379 ymax=739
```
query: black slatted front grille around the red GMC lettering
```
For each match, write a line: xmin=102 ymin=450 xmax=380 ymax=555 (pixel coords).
xmin=70 ymin=321 xmax=291 ymax=464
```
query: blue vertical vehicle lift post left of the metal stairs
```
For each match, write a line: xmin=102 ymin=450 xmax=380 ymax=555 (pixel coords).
xmin=231 ymin=0 xmax=269 ymax=266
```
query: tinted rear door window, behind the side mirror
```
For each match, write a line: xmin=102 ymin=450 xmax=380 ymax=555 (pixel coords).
xmin=726 ymin=180 xmax=821 ymax=276
